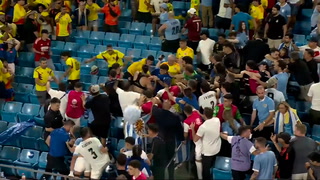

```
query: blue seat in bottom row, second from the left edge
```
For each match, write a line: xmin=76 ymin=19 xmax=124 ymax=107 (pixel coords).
xmin=14 ymin=149 xmax=40 ymax=179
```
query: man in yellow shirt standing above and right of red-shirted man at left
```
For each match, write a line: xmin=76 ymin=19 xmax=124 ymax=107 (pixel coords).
xmin=55 ymin=6 xmax=72 ymax=41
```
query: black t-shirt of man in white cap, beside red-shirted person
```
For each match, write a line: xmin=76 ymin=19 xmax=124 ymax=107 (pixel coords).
xmin=85 ymin=94 xmax=111 ymax=125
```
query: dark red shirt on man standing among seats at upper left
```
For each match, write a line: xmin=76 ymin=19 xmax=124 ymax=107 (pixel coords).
xmin=33 ymin=38 xmax=51 ymax=61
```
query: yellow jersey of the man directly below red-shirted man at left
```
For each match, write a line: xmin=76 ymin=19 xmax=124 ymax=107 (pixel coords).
xmin=33 ymin=67 xmax=54 ymax=91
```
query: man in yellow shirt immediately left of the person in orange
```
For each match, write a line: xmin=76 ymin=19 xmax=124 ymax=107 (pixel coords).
xmin=86 ymin=0 xmax=101 ymax=31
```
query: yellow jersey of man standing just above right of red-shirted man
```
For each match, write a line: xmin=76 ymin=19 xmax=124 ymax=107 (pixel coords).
xmin=55 ymin=13 xmax=72 ymax=37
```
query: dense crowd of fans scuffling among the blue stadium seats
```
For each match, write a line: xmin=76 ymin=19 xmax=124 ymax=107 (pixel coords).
xmin=0 ymin=0 xmax=320 ymax=180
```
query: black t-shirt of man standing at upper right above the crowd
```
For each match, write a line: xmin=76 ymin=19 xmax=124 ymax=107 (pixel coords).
xmin=267 ymin=14 xmax=287 ymax=39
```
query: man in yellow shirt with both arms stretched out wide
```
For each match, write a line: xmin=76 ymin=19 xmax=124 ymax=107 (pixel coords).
xmin=85 ymin=45 xmax=132 ymax=68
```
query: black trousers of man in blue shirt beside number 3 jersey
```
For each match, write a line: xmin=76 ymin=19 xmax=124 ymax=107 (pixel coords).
xmin=41 ymin=154 xmax=69 ymax=180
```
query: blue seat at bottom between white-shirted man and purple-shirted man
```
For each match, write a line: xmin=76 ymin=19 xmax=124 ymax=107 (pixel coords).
xmin=212 ymin=156 xmax=232 ymax=179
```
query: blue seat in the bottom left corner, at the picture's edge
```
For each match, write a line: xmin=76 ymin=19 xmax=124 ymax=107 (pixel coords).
xmin=0 ymin=146 xmax=21 ymax=176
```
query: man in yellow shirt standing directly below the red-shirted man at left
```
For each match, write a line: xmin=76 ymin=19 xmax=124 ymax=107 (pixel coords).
xmin=33 ymin=58 xmax=58 ymax=105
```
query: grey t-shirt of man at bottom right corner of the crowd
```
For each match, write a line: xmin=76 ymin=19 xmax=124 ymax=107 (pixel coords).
xmin=290 ymin=136 xmax=317 ymax=174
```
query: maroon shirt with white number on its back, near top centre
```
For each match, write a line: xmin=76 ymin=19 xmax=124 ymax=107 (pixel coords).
xmin=184 ymin=16 xmax=202 ymax=41
